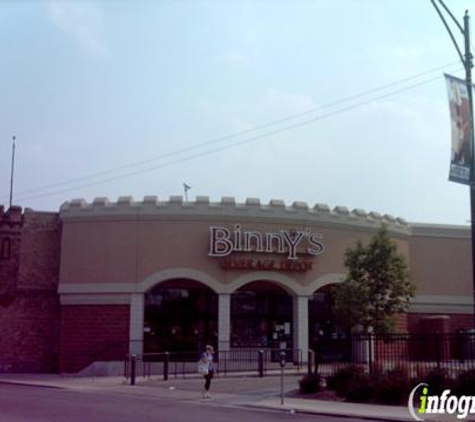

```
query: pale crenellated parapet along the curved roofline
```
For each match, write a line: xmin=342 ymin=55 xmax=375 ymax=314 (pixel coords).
xmin=60 ymin=196 xmax=411 ymax=235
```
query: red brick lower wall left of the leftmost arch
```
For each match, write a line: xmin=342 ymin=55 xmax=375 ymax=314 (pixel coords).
xmin=60 ymin=305 xmax=130 ymax=372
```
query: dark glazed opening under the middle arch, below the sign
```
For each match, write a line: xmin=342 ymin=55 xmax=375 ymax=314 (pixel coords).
xmin=231 ymin=281 xmax=293 ymax=349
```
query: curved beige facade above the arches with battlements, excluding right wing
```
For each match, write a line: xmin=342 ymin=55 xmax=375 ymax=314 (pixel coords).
xmin=56 ymin=195 xmax=410 ymax=294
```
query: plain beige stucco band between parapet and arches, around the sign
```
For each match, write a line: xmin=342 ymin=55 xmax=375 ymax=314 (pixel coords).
xmin=61 ymin=219 xmax=380 ymax=286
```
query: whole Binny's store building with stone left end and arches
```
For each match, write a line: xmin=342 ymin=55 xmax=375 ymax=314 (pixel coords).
xmin=0 ymin=196 xmax=473 ymax=372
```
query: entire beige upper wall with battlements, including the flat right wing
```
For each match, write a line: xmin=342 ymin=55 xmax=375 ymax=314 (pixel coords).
xmin=59 ymin=197 xmax=473 ymax=314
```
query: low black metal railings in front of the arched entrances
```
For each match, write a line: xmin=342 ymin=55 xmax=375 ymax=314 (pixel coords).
xmin=124 ymin=348 xmax=303 ymax=379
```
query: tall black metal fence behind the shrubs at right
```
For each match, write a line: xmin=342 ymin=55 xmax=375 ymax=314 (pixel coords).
xmin=314 ymin=332 xmax=475 ymax=378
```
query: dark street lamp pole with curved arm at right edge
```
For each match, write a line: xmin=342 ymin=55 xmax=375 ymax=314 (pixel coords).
xmin=431 ymin=0 xmax=475 ymax=328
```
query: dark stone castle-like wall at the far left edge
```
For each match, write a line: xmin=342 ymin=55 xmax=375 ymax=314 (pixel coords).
xmin=0 ymin=207 xmax=61 ymax=372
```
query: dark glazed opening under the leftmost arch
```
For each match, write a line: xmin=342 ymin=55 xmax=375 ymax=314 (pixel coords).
xmin=144 ymin=279 xmax=218 ymax=353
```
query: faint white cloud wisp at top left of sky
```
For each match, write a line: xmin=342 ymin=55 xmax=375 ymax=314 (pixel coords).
xmin=48 ymin=2 xmax=111 ymax=57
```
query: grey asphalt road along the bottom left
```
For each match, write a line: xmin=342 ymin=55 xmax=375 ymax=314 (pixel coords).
xmin=0 ymin=384 xmax=384 ymax=422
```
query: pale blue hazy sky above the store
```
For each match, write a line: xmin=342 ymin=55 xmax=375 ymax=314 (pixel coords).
xmin=0 ymin=0 xmax=475 ymax=225
